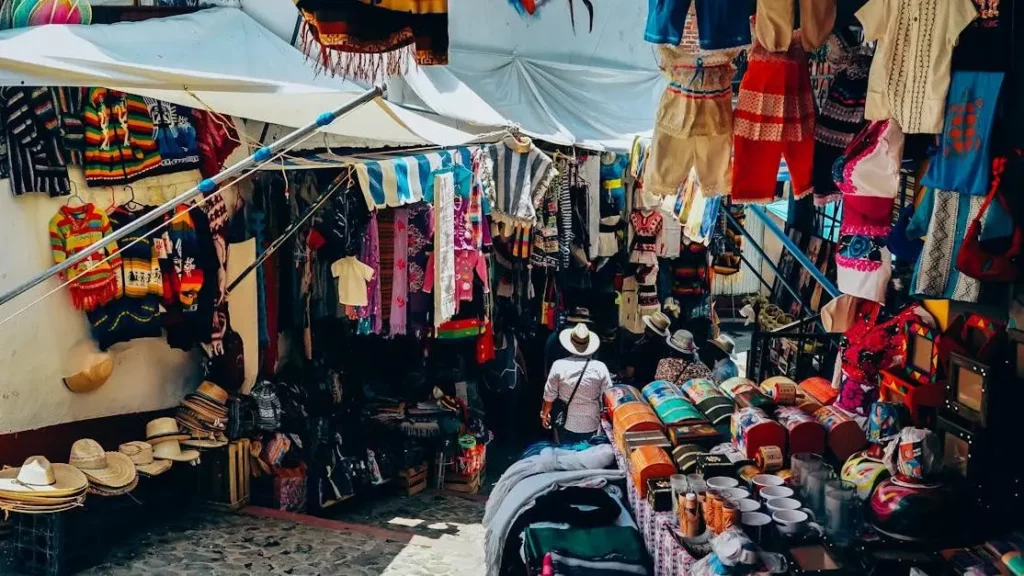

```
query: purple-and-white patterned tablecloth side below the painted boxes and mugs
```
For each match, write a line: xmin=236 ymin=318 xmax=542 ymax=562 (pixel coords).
xmin=601 ymin=420 xmax=696 ymax=576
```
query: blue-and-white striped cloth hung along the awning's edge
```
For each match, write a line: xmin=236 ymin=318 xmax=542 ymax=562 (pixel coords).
xmin=355 ymin=148 xmax=473 ymax=210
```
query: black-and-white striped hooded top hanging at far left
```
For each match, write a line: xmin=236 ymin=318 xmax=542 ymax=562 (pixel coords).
xmin=0 ymin=87 xmax=71 ymax=197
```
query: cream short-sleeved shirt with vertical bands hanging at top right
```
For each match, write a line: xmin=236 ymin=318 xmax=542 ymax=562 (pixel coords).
xmin=857 ymin=0 xmax=978 ymax=134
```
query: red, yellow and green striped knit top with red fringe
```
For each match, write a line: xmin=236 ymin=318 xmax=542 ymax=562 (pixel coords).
xmin=49 ymin=204 xmax=121 ymax=311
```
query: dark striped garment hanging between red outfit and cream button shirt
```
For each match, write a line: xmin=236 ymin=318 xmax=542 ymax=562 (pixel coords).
xmin=814 ymin=34 xmax=871 ymax=206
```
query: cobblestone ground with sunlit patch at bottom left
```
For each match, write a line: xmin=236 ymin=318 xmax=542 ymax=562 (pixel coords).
xmin=0 ymin=493 xmax=484 ymax=576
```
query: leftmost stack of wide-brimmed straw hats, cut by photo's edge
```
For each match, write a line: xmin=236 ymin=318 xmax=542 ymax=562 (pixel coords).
xmin=0 ymin=456 xmax=89 ymax=513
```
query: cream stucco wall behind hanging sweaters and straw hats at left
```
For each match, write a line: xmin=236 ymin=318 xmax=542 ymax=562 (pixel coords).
xmin=0 ymin=147 xmax=245 ymax=434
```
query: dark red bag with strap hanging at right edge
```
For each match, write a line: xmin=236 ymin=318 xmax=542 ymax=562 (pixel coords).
xmin=956 ymin=158 xmax=1024 ymax=282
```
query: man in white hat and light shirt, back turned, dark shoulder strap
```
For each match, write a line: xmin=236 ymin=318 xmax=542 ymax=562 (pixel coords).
xmin=541 ymin=323 xmax=611 ymax=444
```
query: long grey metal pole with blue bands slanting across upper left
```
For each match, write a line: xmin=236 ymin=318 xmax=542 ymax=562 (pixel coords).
xmin=0 ymin=87 xmax=384 ymax=306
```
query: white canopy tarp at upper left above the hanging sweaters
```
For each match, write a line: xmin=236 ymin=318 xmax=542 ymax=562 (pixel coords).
xmin=0 ymin=8 xmax=499 ymax=147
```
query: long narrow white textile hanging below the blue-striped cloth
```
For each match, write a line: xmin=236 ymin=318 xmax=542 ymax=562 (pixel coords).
xmin=433 ymin=168 xmax=457 ymax=326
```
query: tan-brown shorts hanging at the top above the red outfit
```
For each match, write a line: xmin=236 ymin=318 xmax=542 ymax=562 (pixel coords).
xmin=754 ymin=0 xmax=837 ymax=52
